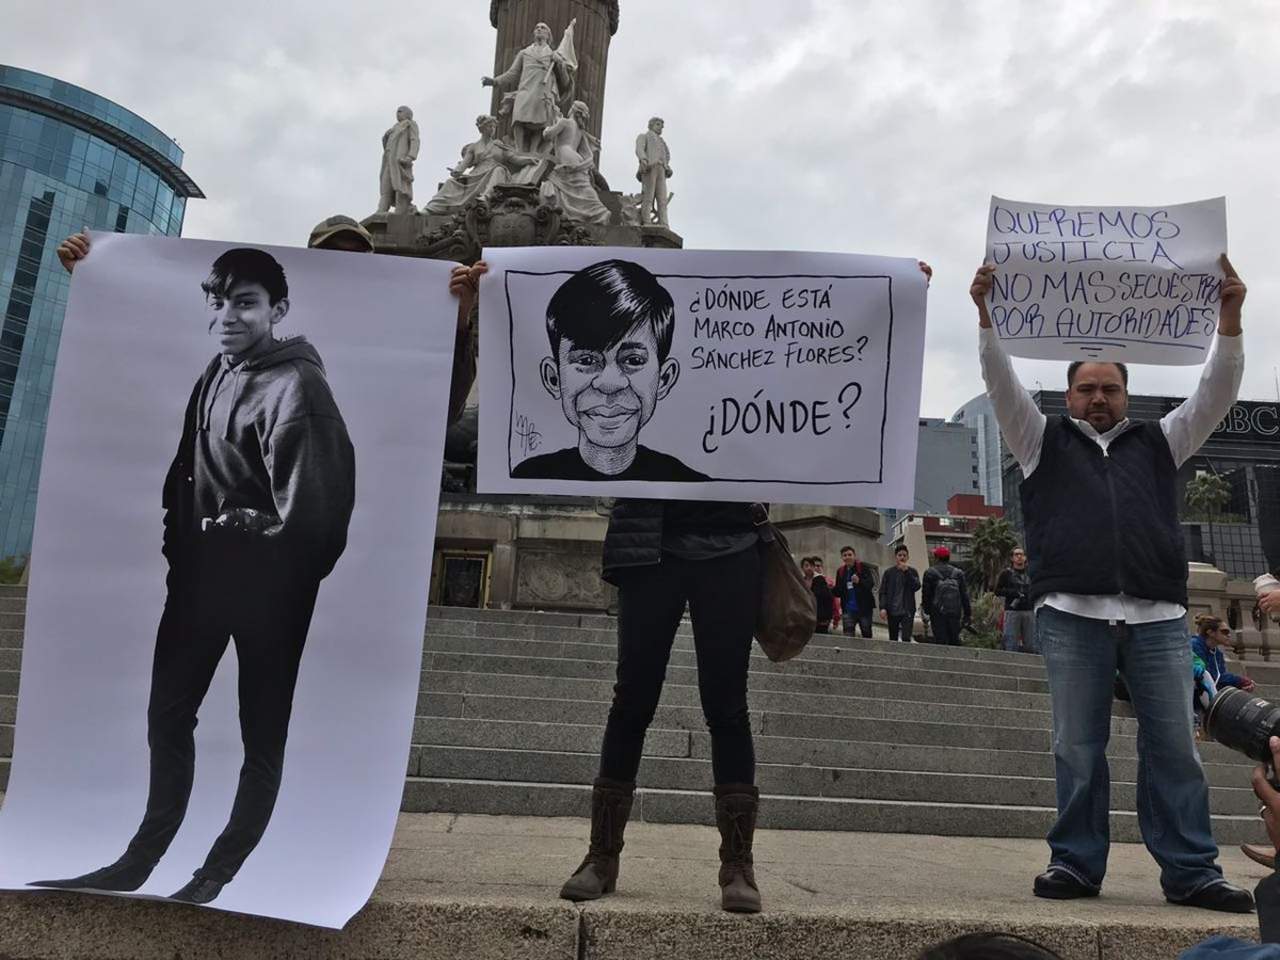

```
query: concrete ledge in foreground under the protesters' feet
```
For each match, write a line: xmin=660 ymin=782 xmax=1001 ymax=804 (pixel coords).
xmin=0 ymin=813 xmax=1263 ymax=960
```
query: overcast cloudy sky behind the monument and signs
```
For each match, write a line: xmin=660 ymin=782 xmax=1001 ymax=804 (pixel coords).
xmin=0 ymin=0 xmax=1280 ymax=416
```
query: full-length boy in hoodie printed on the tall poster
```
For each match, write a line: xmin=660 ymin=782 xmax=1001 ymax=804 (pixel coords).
xmin=35 ymin=248 xmax=356 ymax=904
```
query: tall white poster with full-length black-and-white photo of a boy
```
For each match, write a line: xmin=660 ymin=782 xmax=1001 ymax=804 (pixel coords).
xmin=0 ymin=233 xmax=458 ymax=927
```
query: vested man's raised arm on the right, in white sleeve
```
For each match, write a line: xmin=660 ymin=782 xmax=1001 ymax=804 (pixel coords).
xmin=1160 ymin=253 xmax=1248 ymax=466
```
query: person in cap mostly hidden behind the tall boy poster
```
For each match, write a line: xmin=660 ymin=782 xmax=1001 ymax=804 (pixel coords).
xmin=58 ymin=222 xmax=489 ymax=424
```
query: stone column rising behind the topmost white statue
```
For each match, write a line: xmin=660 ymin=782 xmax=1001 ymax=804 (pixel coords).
xmin=489 ymin=0 xmax=618 ymax=146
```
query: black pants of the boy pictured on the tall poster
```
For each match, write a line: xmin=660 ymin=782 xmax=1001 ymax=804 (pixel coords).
xmin=128 ymin=534 xmax=320 ymax=883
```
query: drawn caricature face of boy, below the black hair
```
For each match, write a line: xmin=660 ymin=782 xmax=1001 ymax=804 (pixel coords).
xmin=540 ymin=323 xmax=680 ymax=447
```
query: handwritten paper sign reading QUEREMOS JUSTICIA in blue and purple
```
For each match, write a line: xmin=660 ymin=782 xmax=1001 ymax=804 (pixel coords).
xmin=986 ymin=197 xmax=1226 ymax=365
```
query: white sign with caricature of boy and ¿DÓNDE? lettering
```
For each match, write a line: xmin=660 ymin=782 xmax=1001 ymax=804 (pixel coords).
xmin=477 ymin=247 xmax=925 ymax=507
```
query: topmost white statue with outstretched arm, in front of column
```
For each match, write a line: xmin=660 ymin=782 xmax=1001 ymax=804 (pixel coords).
xmin=480 ymin=19 xmax=577 ymax=154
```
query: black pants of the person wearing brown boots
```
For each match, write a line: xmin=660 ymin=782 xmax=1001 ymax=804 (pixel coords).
xmin=600 ymin=547 xmax=762 ymax=783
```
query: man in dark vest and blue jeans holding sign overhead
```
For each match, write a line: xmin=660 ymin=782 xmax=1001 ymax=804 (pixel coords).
xmin=969 ymin=256 xmax=1253 ymax=913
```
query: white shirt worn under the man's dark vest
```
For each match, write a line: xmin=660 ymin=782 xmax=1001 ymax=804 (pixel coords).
xmin=978 ymin=328 xmax=1244 ymax=623
